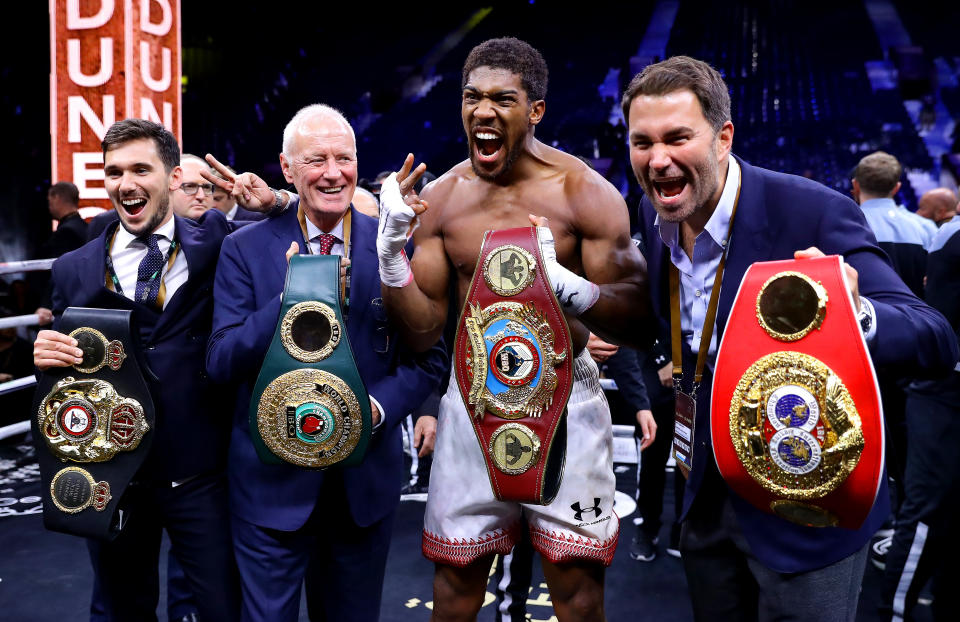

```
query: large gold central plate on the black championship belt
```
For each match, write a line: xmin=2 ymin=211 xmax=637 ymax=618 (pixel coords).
xmin=37 ymin=376 xmax=150 ymax=462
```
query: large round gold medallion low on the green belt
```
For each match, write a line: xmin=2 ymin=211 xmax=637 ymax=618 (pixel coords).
xmin=258 ymin=369 xmax=362 ymax=468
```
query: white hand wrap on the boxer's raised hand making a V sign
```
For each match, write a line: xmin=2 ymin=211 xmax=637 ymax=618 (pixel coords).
xmin=377 ymin=173 xmax=420 ymax=287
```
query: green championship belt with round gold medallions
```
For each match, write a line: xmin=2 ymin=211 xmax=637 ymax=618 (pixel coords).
xmin=250 ymin=255 xmax=373 ymax=469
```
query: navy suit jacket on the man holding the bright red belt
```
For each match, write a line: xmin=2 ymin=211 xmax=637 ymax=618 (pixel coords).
xmin=640 ymin=158 xmax=958 ymax=572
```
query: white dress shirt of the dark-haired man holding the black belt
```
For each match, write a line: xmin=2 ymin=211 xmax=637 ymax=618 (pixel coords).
xmin=110 ymin=218 xmax=189 ymax=309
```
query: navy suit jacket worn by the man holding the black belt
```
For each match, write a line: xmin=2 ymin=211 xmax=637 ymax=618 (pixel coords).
xmin=52 ymin=210 xmax=232 ymax=481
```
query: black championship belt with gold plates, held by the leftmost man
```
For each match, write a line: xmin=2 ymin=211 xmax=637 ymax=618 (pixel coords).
xmin=31 ymin=307 xmax=156 ymax=540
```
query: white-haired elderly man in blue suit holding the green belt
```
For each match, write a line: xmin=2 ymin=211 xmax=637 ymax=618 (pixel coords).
xmin=207 ymin=104 xmax=447 ymax=622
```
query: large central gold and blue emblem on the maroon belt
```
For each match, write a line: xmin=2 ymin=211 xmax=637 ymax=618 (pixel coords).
xmin=465 ymin=301 xmax=567 ymax=422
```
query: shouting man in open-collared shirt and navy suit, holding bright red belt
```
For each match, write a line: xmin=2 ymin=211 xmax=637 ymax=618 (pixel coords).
xmin=623 ymin=57 xmax=958 ymax=621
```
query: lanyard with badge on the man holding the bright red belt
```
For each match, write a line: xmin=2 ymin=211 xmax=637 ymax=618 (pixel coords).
xmin=670 ymin=180 xmax=740 ymax=477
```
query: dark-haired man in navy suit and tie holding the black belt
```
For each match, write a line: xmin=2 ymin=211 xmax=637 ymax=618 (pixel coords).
xmin=34 ymin=119 xmax=272 ymax=620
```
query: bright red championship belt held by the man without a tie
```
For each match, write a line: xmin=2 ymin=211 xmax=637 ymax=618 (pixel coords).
xmin=710 ymin=255 xmax=884 ymax=529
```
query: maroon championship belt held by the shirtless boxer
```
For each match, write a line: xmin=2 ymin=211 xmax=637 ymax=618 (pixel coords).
xmin=454 ymin=227 xmax=573 ymax=504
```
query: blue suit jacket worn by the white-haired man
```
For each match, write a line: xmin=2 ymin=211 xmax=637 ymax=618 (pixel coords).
xmin=207 ymin=201 xmax=447 ymax=531
